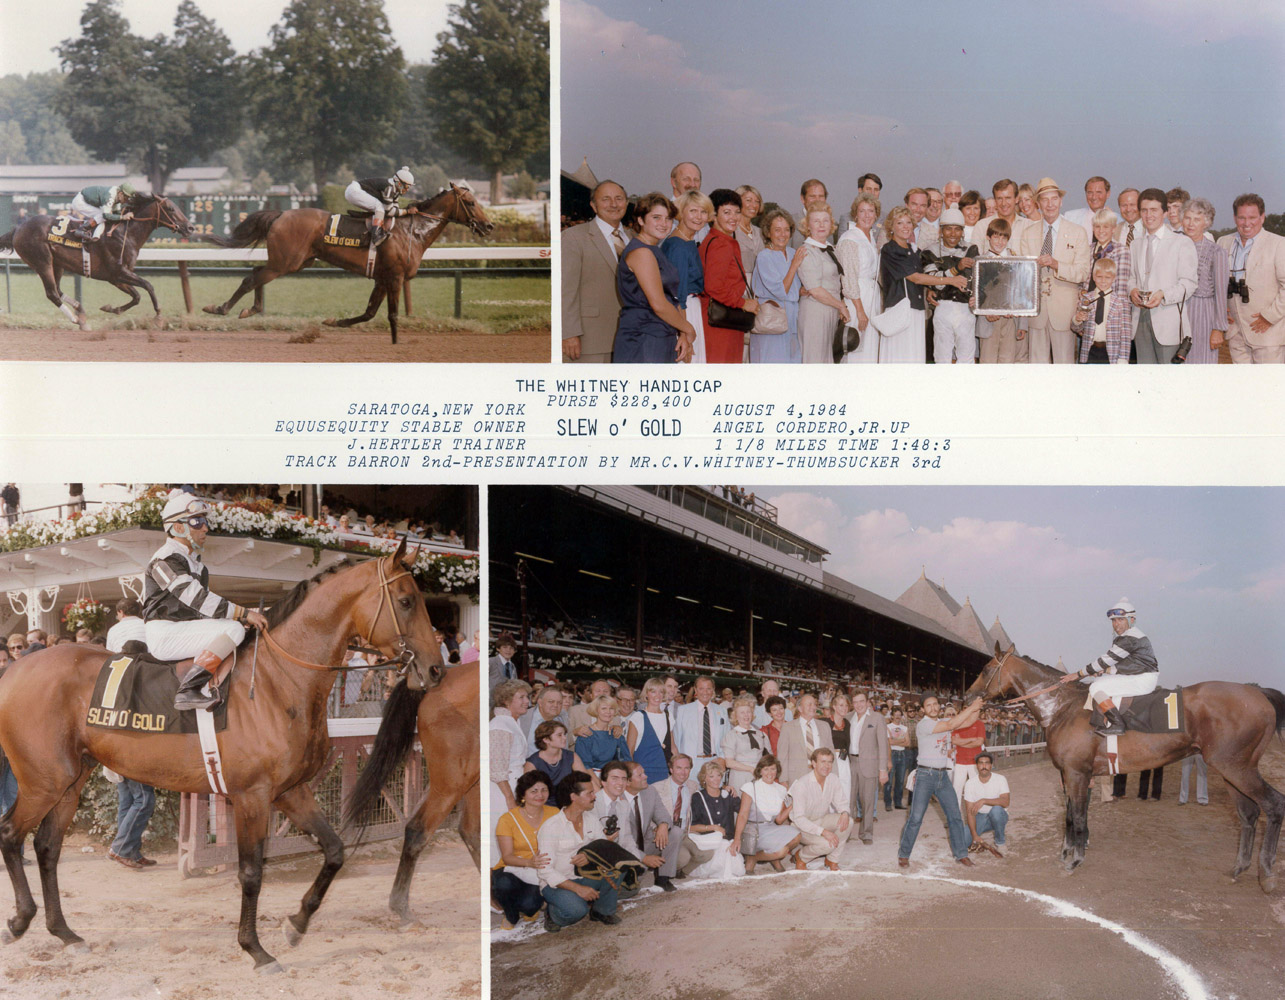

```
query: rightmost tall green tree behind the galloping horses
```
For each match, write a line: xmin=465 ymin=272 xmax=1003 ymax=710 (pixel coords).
xmin=425 ymin=0 xmax=549 ymax=204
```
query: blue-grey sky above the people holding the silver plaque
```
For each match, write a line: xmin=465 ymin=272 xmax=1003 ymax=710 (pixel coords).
xmin=562 ymin=0 xmax=1285 ymax=228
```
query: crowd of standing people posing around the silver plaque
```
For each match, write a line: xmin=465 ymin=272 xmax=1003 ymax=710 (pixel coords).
xmin=562 ymin=162 xmax=1285 ymax=364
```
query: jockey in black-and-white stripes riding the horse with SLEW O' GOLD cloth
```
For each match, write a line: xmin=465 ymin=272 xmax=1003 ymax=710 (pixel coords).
xmin=143 ymin=490 xmax=267 ymax=711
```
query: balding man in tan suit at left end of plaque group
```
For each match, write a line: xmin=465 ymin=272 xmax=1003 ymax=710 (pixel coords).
xmin=562 ymin=180 xmax=635 ymax=364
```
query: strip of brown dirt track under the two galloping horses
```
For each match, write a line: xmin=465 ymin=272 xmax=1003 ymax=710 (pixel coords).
xmin=0 ymin=323 xmax=550 ymax=364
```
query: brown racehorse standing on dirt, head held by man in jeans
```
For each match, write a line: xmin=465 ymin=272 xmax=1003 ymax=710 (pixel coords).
xmin=964 ymin=643 xmax=1285 ymax=892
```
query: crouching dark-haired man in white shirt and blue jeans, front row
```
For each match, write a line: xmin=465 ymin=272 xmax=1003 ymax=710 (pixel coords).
xmin=537 ymin=771 xmax=621 ymax=932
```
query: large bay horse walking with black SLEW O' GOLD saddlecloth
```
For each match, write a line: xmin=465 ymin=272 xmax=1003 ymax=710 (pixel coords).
xmin=0 ymin=539 xmax=447 ymax=972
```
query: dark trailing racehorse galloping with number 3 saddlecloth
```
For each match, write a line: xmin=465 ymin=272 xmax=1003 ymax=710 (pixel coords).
xmin=0 ymin=194 xmax=193 ymax=330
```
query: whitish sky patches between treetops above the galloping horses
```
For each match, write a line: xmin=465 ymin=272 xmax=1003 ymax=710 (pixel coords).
xmin=0 ymin=0 xmax=450 ymax=75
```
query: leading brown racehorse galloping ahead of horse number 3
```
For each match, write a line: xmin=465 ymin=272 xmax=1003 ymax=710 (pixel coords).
xmin=206 ymin=184 xmax=495 ymax=343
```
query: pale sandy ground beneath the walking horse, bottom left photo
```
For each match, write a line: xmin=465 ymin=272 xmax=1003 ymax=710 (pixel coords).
xmin=0 ymin=832 xmax=482 ymax=1000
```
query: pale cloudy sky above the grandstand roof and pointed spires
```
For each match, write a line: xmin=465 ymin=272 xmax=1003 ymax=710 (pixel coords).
xmin=745 ymin=485 xmax=1285 ymax=689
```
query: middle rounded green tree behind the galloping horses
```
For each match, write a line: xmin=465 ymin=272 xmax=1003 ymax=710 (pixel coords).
xmin=253 ymin=0 xmax=406 ymax=190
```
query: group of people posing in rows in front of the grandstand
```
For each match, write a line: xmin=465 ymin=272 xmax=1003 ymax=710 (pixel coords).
xmin=488 ymin=668 xmax=1041 ymax=932
